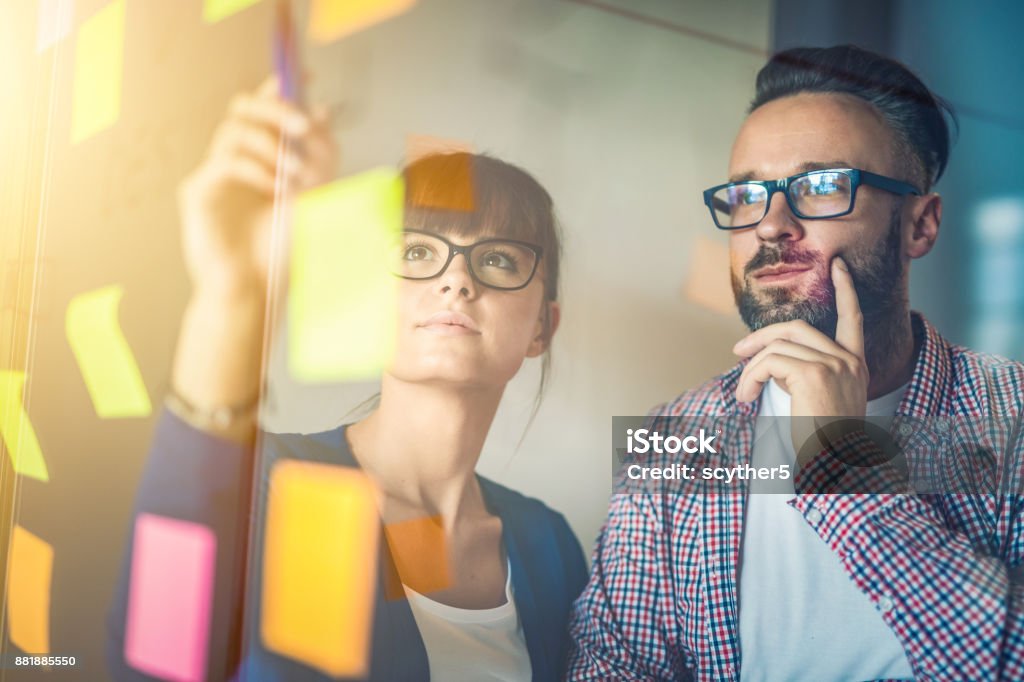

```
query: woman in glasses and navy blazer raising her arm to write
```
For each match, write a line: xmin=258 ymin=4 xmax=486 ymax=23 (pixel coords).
xmin=109 ymin=80 xmax=586 ymax=680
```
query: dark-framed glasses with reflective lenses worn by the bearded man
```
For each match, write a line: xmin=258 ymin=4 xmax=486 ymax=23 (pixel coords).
xmin=703 ymin=168 xmax=921 ymax=229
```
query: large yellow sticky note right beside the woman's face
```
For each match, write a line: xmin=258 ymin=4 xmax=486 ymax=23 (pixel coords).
xmin=288 ymin=169 xmax=404 ymax=382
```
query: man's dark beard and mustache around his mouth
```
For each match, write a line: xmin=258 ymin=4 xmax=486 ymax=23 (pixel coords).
xmin=731 ymin=208 xmax=906 ymax=339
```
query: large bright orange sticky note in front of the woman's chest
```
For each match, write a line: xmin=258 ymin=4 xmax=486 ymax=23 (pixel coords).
xmin=260 ymin=460 xmax=380 ymax=677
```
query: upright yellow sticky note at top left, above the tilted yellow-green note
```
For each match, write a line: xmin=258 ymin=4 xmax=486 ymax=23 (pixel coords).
xmin=71 ymin=0 xmax=125 ymax=144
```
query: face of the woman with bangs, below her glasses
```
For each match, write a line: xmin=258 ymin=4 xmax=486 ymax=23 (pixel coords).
xmin=388 ymin=227 xmax=558 ymax=387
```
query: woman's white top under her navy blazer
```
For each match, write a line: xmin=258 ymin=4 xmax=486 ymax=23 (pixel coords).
xmin=406 ymin=564 xmax=532 ymax=682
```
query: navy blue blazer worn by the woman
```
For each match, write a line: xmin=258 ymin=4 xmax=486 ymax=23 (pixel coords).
xmin=108 ymin=411 xmax=587 ymax=682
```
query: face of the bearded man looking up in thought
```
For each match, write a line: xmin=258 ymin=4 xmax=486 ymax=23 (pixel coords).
xmin=729 ymin=94 xmax=906 ymax=336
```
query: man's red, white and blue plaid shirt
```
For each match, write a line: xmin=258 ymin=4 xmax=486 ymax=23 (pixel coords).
xmin=568 ymin=313 xmax=1024 ymax=680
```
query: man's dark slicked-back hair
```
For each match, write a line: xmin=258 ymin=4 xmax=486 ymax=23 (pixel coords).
xmin=750 ymin=45 xmax=956 ymax=191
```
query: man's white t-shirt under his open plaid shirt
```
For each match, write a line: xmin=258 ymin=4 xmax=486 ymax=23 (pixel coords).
xmin=739 ymin=381 xmax=913 ymax=682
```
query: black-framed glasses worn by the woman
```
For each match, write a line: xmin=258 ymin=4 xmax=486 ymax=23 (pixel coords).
xmin=391 ymin=229 xmax=544 ymax=291
